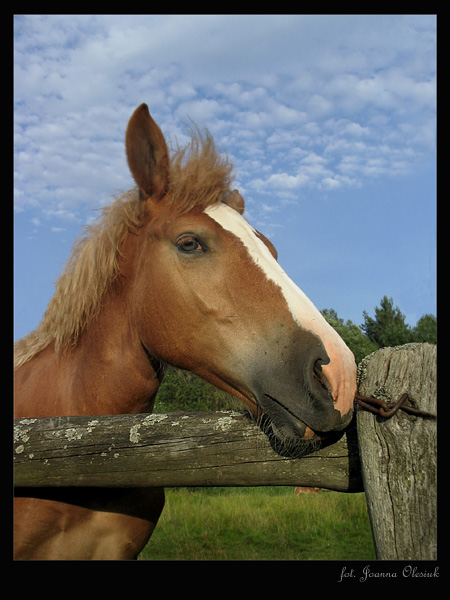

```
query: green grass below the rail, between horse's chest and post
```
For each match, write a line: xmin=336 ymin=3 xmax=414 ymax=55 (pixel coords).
xmin=140 ymin=487 xmax=375 ymax=560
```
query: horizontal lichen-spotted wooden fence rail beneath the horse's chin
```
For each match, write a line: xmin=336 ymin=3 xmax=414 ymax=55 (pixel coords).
xmin=14 ymin=411 xmax=363 ymax=492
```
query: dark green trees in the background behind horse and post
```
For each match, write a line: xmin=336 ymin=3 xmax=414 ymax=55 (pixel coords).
xmin=155 ymin=296 xmax=437 ymax=412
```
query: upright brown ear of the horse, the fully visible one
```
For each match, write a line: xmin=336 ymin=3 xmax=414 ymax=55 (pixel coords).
xmin=125 ymin=104 xmax=169 ymax=200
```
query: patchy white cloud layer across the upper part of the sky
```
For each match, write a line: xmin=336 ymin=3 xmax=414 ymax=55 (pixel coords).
xmin=14 ymin=15 xmax=435 ymax=232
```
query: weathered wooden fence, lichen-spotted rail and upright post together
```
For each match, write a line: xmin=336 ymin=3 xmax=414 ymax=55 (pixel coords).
xmin=14 ymin=344 xmax=436 ymax=560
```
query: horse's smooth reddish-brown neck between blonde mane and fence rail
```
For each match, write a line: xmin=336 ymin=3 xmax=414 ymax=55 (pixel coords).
xmin=15 ymin=292 xmax=160 ymax=417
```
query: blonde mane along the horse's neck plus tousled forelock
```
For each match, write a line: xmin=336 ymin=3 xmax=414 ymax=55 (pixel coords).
xmin=14 ymin=129 xmax=235 ymax=368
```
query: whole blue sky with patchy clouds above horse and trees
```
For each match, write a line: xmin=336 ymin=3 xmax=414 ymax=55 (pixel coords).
xmin=14 ymin=15 xmax=436 ymax=339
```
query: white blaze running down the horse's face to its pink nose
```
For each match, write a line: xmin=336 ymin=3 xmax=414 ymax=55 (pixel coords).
xmin=205 ymin=204 xmax=356 ymax=416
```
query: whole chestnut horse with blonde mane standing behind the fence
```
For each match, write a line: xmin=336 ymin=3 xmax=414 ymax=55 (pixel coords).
xmin=14 ymin=104 xmax=356 ymax=560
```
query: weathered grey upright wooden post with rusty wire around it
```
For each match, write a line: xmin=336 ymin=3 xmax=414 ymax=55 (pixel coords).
xmin=357 ymin=344 xmax=437 ymax=560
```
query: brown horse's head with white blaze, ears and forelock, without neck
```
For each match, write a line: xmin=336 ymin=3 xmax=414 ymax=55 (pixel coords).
xmin=126 ymin=105 xmax=356 ymax=450
